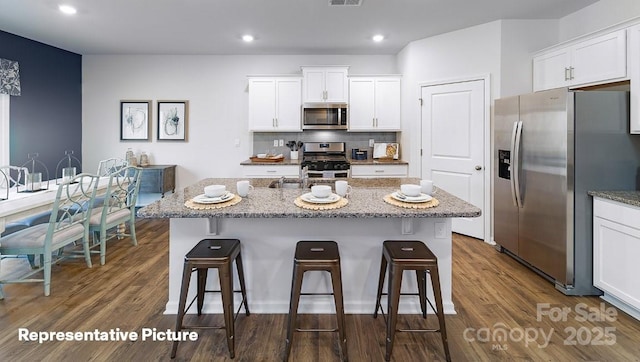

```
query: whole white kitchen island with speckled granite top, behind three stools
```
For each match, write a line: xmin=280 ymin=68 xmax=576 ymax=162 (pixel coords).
xmin=138 ymin=178 xmax=480 ymax=314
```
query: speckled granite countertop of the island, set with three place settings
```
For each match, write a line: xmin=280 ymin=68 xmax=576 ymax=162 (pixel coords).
xmin=138 ymin=178 xmax=480 ymax=218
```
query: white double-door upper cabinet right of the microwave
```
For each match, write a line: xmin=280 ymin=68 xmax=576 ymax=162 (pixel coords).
xmin=348 ymin=76 xmax=400 ymax=131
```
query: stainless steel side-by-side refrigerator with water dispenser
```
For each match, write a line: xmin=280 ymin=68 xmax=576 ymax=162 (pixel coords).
xmin=493 ymin=89 xmax=640 ymax=295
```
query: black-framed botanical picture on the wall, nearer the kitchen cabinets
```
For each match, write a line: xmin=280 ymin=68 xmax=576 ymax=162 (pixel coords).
xmin=157 ymin=101 xmax=189 ymax=141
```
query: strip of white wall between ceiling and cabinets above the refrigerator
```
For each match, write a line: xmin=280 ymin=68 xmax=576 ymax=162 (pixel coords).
xmin=558 ymin=0 xmax=640 ymax=42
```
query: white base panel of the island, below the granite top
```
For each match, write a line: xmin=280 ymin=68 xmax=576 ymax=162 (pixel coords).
xmin=165 ymin=218 xmax=455 ymax=314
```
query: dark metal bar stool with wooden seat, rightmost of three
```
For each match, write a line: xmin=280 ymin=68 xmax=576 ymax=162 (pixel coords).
xmin=373 ymin=240 xmax=451 ymax=361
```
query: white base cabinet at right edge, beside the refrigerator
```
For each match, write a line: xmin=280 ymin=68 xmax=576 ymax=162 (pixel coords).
xmin=593 ymin=197 xmax=640 ymax=319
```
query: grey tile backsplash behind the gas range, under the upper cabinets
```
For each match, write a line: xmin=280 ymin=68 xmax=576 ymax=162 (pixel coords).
xmin=253 ymin=130 xmax=397 ymax=158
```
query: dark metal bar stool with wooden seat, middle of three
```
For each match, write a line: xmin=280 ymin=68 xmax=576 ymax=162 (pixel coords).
xmin=284 ymin=241 xmax=347 ymax=361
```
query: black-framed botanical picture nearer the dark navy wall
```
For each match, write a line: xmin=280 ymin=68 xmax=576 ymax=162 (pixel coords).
xmin=120 ymin=100 xmax=151 ymax=141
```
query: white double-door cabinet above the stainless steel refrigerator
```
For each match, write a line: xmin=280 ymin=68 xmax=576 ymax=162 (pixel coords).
xmin=533 ymin=29 xmax=627 ymax=91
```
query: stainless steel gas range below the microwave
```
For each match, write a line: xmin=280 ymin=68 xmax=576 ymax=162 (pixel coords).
xmin=301 ymin=142 xmax=351 ymax=178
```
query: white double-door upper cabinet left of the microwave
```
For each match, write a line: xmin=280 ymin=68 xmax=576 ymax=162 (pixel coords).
xmin=249 ymin=77 xmax=302 ymax=132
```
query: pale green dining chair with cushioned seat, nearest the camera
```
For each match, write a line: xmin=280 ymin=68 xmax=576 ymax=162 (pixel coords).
xmin=0 ymin=174 xmax=98 ymax=296
